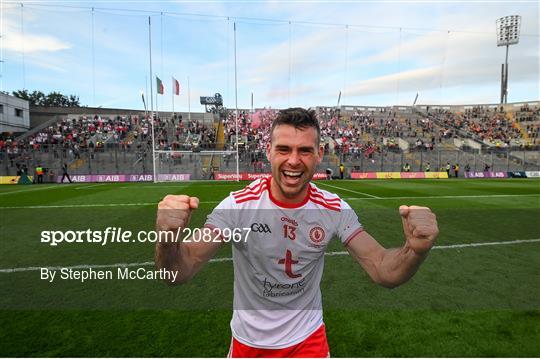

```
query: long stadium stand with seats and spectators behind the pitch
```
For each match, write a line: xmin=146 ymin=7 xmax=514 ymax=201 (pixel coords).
xmin=0 ymin=103 xmax=540 ymax=180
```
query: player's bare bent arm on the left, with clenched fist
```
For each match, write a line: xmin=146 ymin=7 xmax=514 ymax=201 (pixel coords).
xmin=154 ymin=195 xmax=221 ymax=284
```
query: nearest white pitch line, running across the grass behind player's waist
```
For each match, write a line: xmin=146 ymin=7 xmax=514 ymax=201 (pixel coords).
xmin=0 ymin=238 xmax=540 ymax=273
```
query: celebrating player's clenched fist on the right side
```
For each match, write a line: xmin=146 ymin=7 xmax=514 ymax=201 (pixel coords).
xmin=399 ymin=206 xmax=439 ymax=254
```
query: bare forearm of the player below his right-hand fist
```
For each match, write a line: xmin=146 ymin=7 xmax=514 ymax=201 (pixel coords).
xmin=376 ymin=244 xmax=427 ymax=288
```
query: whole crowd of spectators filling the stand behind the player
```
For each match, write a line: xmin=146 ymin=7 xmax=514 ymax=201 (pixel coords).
xmin=0 ymin=106 xmax=540 ymax=171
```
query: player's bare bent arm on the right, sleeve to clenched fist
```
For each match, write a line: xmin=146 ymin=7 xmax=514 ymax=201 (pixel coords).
xmin=347 ymin=206 xmax=439 ymax=288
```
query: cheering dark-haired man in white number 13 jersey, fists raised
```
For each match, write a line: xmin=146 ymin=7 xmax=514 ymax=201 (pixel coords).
xmin=155 ymin=108 xmax=438 ymax=357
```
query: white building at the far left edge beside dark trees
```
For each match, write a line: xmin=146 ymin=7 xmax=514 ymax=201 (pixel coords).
xmin=0 ymin=92 xmax=30 ymax=133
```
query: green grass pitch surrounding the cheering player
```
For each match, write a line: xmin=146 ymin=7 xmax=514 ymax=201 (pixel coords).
xmin=0 ymin=179 xmax=540 ymax=357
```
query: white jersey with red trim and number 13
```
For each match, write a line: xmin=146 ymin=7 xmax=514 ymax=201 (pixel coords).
xmin=205 ymin=178 xmax=362 ymax=349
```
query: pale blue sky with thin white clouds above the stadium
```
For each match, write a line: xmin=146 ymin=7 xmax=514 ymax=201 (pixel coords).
xmin=0 ymin=0 xmax=540 ymax=112
